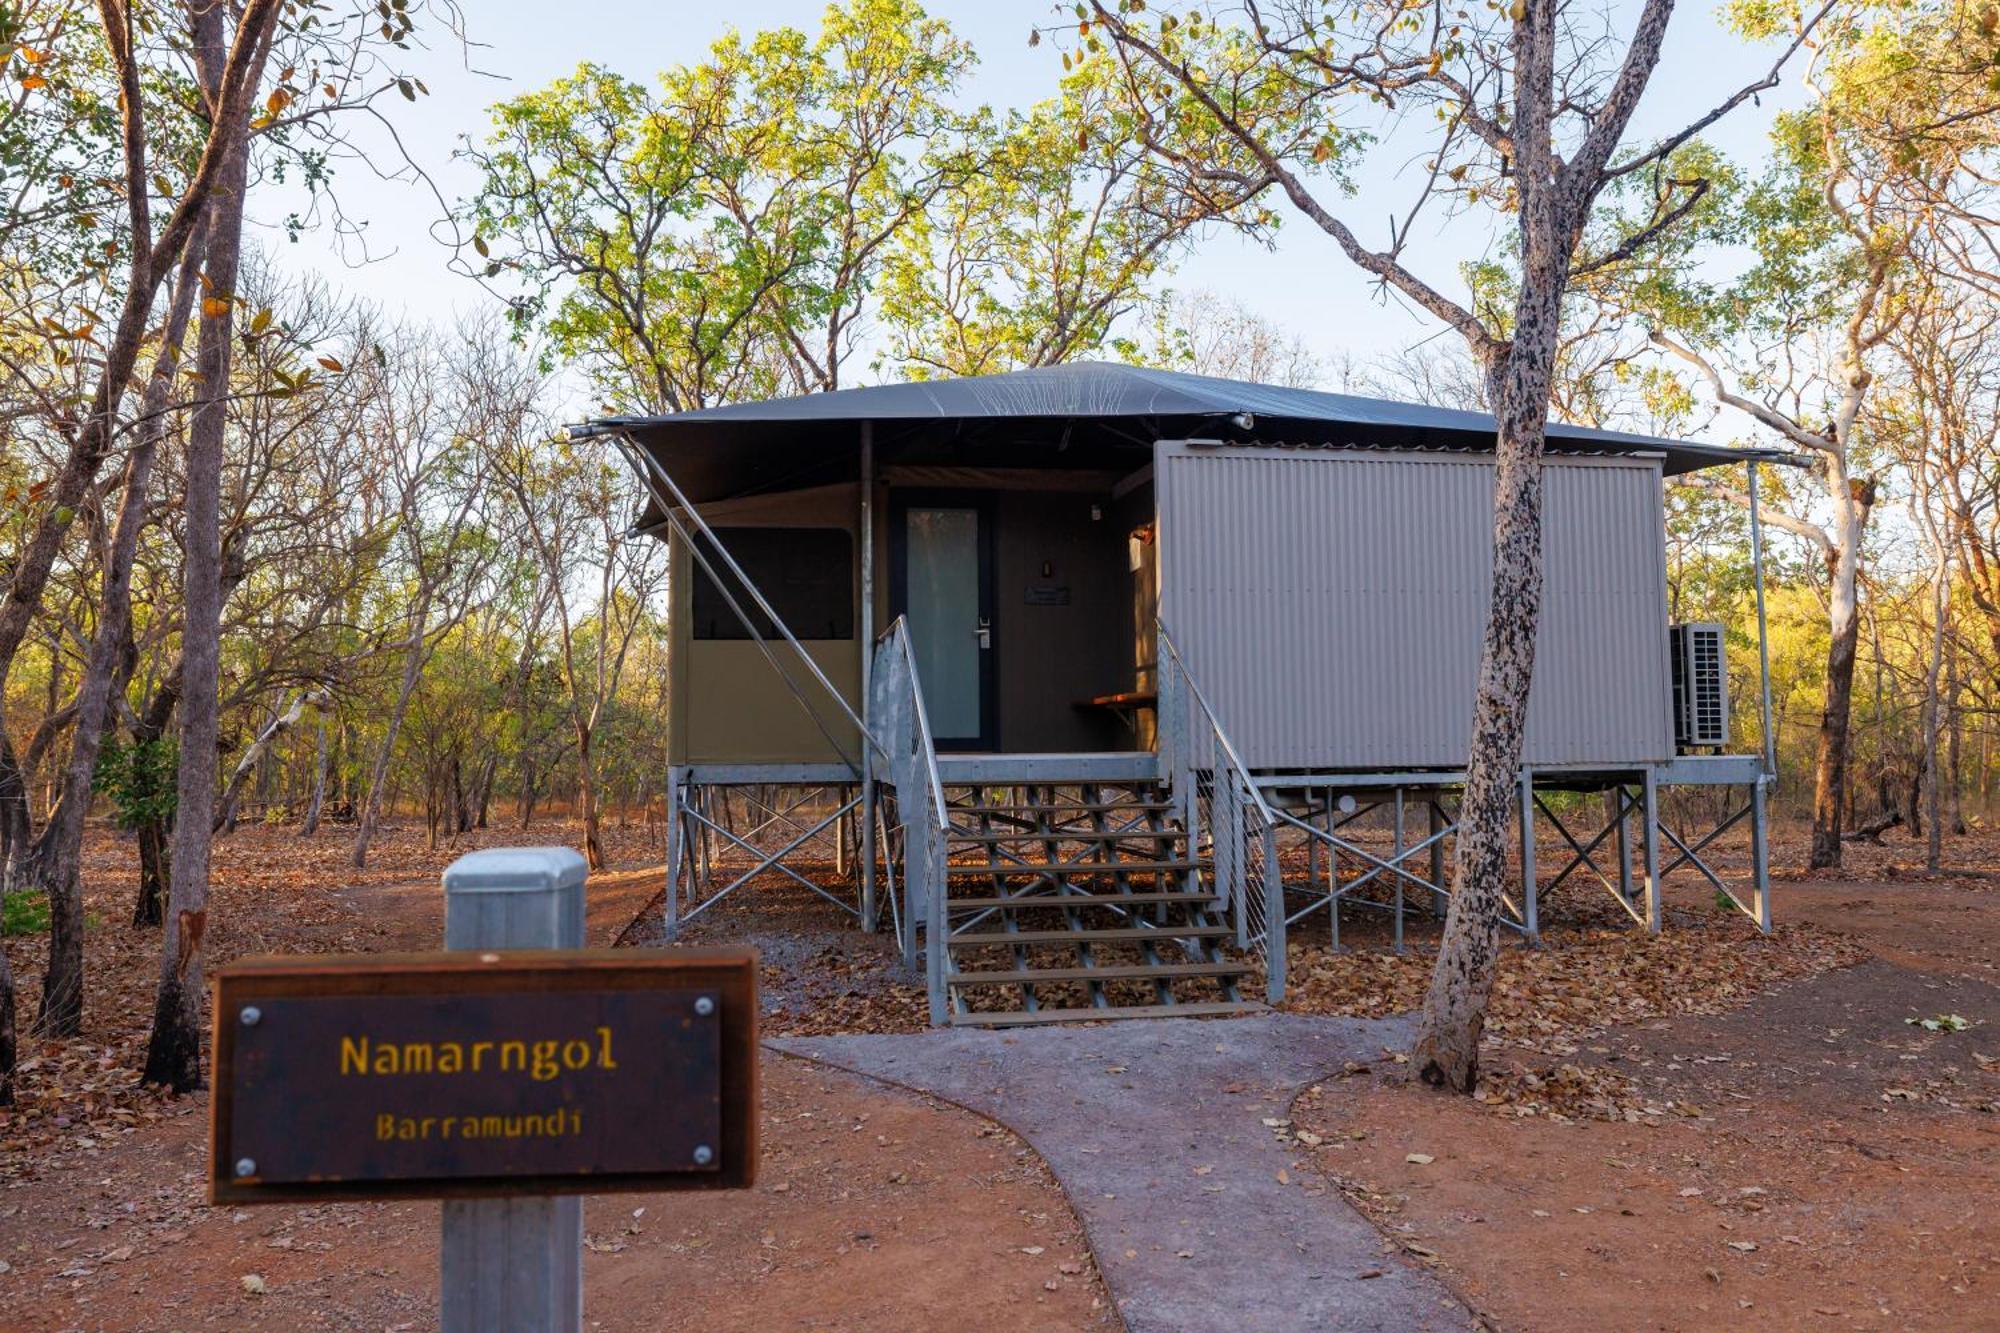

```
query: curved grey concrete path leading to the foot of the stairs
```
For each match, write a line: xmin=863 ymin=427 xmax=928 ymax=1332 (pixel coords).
xmin=768 ymin=1015 xmax=1472 ymax=1333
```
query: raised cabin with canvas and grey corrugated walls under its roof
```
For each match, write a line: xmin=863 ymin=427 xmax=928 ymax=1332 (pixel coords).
xmin=578 ymin=364 xmax=1762 ymax=1020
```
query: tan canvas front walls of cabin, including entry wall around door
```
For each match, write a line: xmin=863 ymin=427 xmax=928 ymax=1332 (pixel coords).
xmin=668 ymin=468 xmax=1152 ymax=765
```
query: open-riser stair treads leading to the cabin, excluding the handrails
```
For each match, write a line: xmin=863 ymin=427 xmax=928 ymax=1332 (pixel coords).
xmin=944 ymin=785 xmax=1258 ymax=1027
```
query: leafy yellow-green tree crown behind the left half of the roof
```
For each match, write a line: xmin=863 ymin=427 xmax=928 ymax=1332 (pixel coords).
xmin=464 ymin=0 xmax=972 ymax=410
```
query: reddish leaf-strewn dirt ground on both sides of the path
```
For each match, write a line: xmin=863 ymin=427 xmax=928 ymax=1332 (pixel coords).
xmin=0 ymin=804 xmax=2000 ymax=1329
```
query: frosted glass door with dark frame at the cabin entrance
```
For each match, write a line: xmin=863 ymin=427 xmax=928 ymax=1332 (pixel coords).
xmin=896 ymin=502 xmax=994 ymax=751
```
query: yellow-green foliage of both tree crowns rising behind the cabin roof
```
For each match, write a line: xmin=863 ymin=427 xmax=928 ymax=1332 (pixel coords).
xmin=466 ymin=0 xmax=1272 ymax=400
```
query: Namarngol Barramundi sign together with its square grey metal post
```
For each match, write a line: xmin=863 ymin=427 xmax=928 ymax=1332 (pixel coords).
xmin=210 ymin=849 xmax=758 ymax=1333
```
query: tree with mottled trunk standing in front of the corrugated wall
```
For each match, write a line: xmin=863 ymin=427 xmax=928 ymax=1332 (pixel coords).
xmin=1070 ymin=0 xmax=1804 ymax=1093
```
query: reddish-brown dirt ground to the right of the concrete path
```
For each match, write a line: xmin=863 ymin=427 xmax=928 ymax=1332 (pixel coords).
xmin=1294 ymin=820 xmax=2000 ymax=1329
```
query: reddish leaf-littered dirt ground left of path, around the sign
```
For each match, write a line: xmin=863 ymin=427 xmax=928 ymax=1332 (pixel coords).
xmin=0 ymin=829 xmax=1116 ymax=1331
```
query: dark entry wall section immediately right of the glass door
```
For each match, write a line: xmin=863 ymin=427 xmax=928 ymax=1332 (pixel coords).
xmin=994 ymin=490 xmax=1138 ymax=755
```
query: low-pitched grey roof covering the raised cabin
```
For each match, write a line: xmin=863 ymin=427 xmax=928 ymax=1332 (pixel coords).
xmin=576 ymin=362 xmax=1788 ymax=474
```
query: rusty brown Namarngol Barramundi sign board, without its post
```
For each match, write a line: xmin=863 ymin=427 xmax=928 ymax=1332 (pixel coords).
xmin=210 ymin=949 xmax=758 ymax=1203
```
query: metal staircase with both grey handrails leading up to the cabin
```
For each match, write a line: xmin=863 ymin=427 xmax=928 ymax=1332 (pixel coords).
xmin=870 ymin=618 xmax=1284 ymax=1027
